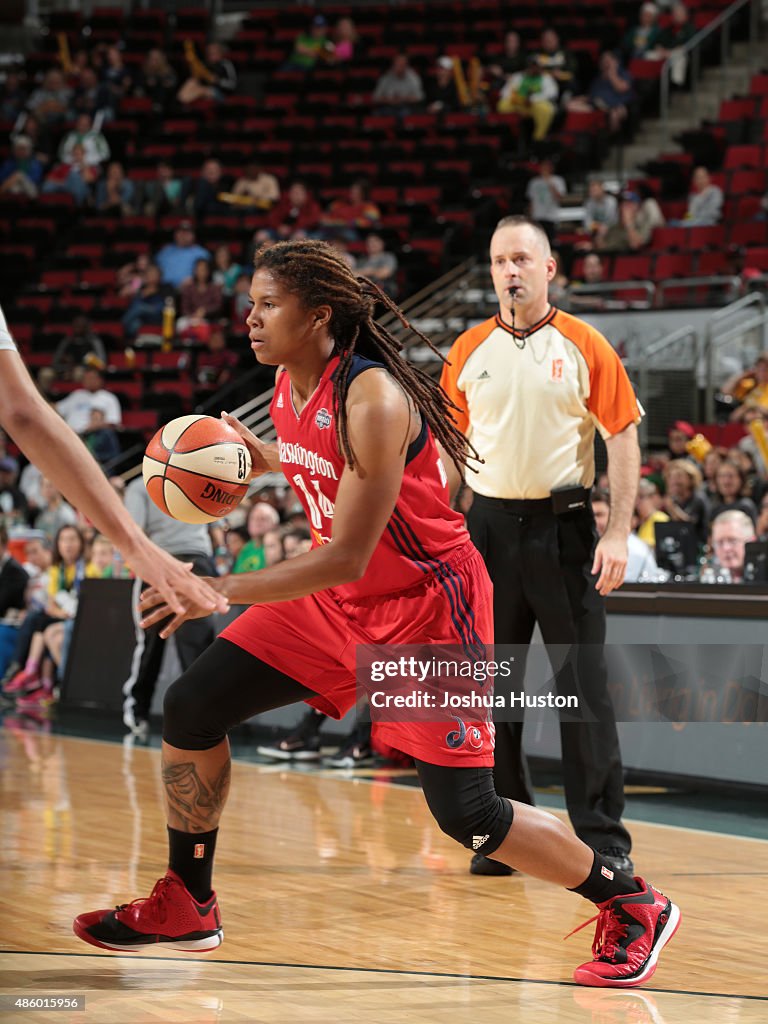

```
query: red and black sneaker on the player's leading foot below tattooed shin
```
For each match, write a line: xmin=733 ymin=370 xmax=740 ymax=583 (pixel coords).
xmin=72 ymin=870 xmax=224 ymax=952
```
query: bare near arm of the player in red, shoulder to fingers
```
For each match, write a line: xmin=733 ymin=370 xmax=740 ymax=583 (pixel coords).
xmin=140 ymin=371 xmax=415 ymax=636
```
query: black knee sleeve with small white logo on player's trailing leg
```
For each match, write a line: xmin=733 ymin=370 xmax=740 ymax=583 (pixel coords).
xmin=416 ymin=761 xmax=513 ymax=856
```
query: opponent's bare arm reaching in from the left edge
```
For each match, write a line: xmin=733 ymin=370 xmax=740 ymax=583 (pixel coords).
xmin=0 ymin=299 xmax=228 ymax=612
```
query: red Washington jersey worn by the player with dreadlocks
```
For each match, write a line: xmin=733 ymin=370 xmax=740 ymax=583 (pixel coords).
xmin=269 ymin=355 xmax=470 ymax=600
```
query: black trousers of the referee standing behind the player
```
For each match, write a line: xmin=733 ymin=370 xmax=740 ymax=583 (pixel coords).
xmin=467 ymin=495 xmax=632 ymax=853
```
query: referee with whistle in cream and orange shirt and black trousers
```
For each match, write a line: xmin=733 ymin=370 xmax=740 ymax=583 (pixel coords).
xmin=441 ymin=216 xmax=641 ymax=874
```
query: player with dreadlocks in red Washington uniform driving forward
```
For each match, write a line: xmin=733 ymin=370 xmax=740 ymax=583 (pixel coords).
xmin=74 ymin=241 xmax=680 ymax=986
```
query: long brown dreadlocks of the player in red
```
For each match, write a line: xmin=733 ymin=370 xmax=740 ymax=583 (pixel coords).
xmin=254 ymin=240 xmax=478 ymax=469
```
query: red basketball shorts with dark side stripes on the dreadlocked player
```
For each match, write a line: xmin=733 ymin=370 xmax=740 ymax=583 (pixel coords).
xmin=221 ymin=544 xmax=494 ymax=767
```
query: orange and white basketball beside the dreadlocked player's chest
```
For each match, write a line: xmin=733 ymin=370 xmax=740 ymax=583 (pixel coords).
xmin=142 ymin=416 xmax=251 ymax=523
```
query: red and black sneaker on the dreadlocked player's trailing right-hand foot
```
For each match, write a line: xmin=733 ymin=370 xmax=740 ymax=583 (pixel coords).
xmin=570 ymin=879 xmax=680 ymax=988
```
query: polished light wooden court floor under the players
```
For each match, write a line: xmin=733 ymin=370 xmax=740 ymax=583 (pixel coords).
xmin=0 ymin=728 xmax=768 ymax=1024
